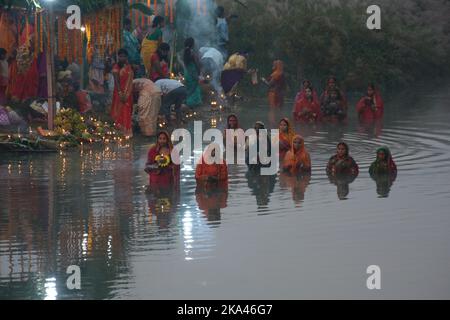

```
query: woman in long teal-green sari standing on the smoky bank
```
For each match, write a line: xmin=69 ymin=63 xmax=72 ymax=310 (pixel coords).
xmin=184 ymin=38 xmax=202 ymax=107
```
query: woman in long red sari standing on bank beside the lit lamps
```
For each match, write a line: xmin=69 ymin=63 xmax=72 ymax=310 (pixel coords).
xmin=111 ymin=49 xmax=134 ymax=137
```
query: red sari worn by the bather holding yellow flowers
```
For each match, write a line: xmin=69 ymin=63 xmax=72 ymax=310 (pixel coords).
xmin=147 ymin=131 xmax=180 ymax=189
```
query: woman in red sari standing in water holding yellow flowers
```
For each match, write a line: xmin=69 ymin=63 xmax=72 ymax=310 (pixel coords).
xmin=145 ymin=131 xmax=180 ymax=190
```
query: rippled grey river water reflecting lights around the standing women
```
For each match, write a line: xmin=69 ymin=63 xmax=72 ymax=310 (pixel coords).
xmin=0 ymin=87 xmax=450 ymax=299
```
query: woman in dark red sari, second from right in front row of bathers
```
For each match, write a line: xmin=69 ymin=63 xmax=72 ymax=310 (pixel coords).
xmin=327 ymin=142 xmax=359 ymax=176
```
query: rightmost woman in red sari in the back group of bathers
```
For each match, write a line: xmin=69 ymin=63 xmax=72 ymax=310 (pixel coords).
xmin=356 ymin=84 xmax=384 ymax=123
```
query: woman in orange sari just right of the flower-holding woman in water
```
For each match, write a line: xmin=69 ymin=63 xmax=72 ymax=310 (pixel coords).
xmin=195 ymin=143 xmax=228 ymax=189
